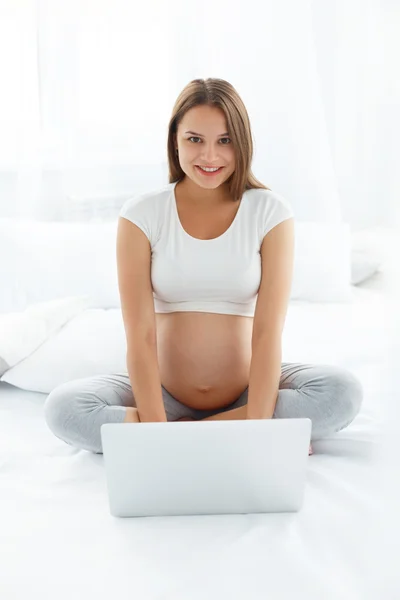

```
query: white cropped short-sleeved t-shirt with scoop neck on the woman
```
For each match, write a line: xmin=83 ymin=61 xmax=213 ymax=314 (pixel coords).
xmin=119 ymin=182 xmax=294 ymax=317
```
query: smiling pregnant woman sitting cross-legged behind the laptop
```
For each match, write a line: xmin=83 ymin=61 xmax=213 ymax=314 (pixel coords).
xmin=45 ymin=79 xmax=363 ymax=453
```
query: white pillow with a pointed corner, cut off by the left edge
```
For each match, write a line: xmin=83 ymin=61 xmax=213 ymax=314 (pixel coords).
xmin=0 ymin=296 xmax=90 ymax=376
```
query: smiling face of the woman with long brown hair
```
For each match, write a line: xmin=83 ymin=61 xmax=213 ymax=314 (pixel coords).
xmin=175 ymin=105 xmax=235 ymax=190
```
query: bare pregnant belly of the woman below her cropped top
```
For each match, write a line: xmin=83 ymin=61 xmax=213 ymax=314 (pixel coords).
xmin=156 ymin=312 xmax=253 ymax=410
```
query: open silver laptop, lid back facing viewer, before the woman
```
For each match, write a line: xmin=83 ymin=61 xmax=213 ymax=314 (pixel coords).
xmin=101 ymin=418 xmax=311 ymax=517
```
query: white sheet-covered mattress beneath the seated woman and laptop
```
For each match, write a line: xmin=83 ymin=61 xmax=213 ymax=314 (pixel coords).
xmin=0 ymin=288 xmax=394 ymax=600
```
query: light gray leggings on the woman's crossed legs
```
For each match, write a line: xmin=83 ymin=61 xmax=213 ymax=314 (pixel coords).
xmin=44 ymin=363 xmax=363 ymax=454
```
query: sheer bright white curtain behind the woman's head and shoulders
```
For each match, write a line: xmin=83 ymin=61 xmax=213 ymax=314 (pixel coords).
xmin=0 ymin=0 xmax=400 ymax=230
